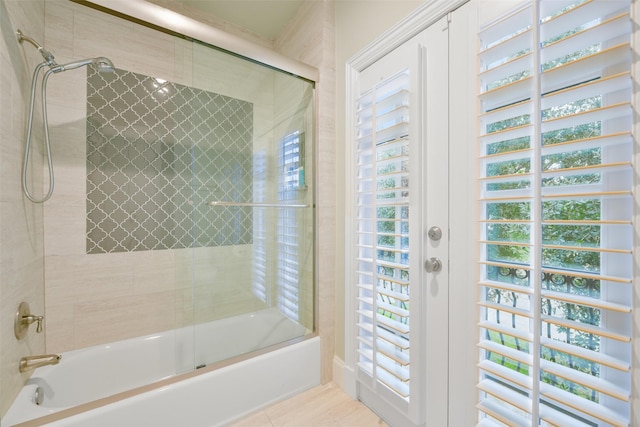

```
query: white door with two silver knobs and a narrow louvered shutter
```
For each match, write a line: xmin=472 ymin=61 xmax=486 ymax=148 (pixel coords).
xmin=349 ymin=14 xmax=449 ymax=427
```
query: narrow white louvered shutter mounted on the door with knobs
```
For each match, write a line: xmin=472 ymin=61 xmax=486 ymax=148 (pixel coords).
xmin=356 ymin=72 xmax=410 ymax=400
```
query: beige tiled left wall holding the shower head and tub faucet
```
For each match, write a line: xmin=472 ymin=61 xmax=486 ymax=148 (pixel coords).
xmin=0 ymin=0 xmax=44 ymax=417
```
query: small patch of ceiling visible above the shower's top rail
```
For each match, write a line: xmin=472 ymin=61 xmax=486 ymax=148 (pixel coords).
xmin=182 ymin=0 xmax=304 ymax=40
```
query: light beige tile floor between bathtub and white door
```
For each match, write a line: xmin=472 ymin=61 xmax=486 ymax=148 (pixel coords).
xmin=231 ymin=383 xmax=388 ymax=427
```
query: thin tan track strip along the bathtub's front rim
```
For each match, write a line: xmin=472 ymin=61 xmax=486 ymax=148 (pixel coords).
xmin=12 ymin=331 xmax=319 ymax=427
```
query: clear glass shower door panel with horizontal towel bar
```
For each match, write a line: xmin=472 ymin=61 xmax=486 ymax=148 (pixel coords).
xmin=189 ymin=44 xmax=315 ymax=367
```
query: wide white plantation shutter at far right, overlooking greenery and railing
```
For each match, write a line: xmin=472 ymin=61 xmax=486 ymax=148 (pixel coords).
xmin=477 ymin=0 xmax=633 ymax=427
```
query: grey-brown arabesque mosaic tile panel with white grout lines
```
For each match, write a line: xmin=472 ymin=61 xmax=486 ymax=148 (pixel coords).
xmin=87 ymin=67 xmax=253 ymax=254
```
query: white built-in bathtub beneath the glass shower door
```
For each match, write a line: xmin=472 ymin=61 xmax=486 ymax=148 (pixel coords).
xmin=1 ymin=309 xmax=320 ymax=427
